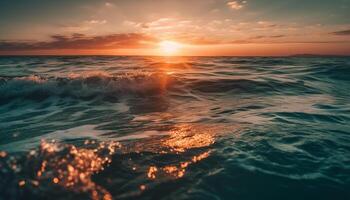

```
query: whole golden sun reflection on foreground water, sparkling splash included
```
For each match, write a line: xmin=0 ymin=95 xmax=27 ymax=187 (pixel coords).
xmin=0 ymin=124 xmax=232 ymax=200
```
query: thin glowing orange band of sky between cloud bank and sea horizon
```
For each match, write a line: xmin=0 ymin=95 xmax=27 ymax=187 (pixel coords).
xmin=1 ymin=43 xmax=350 ymax=56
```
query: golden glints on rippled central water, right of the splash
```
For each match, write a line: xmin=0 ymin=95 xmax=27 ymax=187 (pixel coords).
xmin=123 ymin=123 xmax=227 ymax=181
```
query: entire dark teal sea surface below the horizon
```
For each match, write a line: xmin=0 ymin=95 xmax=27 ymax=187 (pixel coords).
xmin=0 ymin=57 xmax=350 ymax=200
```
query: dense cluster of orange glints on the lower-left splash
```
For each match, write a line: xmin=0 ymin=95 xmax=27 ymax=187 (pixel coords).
xmin=26 ymin=141 xmax=120 ymax=200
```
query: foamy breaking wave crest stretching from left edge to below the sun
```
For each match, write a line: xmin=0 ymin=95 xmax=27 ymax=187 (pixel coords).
xmin=0 ymin=71 xmax=171 ymax=102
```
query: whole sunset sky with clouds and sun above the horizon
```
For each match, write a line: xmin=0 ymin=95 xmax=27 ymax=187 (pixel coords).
xmin=0 ymin=0 xmax=350 ymax=56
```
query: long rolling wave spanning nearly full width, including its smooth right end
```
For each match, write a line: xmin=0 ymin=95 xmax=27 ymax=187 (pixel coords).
xmin=0 ymin=71 xmax=319 ymax=103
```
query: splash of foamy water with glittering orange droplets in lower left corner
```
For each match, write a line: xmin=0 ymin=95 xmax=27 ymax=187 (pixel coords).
xmin=1 ymin=141 xmax=121 ymax=200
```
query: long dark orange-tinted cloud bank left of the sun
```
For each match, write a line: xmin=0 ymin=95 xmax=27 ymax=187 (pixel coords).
xmin=0 ymin=33 xmax=157 ymax=51
